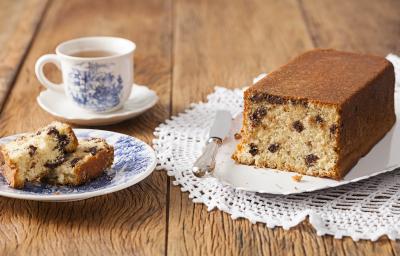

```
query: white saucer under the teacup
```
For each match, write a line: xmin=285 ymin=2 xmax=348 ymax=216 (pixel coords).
xmin=37 ymin=84 xmax=158 ymax=126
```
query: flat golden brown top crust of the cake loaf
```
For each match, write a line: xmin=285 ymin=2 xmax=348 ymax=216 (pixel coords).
xmin=249 ymin=49 xmax=393 ymax=104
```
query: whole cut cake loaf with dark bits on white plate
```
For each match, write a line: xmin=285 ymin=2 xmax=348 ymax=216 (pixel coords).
xmin=232 ymin=49 xmax=396 ymax=179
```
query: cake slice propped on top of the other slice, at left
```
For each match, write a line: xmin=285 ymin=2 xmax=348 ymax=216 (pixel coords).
xmin=0 ymin=122 xmax=78 ymax=188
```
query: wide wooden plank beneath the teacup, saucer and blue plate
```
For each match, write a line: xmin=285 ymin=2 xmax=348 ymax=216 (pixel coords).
xmin=0 ymin=0 xmax=172 ymax=255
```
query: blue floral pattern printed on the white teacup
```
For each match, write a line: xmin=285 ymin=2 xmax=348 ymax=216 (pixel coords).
xmin=68 ymin=62 xmax=123 ymax=111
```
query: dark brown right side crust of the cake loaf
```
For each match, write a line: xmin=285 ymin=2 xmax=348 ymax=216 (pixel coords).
xmin=338 ymin=62 xmax=396 ymax=177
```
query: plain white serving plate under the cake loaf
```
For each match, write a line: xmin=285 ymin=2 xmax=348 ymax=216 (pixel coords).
xmin=213 ymin=93 xmax=400 ymax=195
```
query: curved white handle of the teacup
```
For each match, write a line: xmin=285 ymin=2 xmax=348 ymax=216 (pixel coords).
xmin=35 ymin=54 xmax=64 ymax=92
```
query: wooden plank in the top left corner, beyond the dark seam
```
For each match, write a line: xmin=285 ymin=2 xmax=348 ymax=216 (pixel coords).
xmin=0 ymin=0 xmax=47 ymax=111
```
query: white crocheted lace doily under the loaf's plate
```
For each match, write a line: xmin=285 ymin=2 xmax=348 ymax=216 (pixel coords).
xmin=153 ymin=54 xmax=400 ymax=241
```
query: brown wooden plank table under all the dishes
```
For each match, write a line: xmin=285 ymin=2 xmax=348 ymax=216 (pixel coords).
xmin=0 ymin=0 xmax=400 ymax=255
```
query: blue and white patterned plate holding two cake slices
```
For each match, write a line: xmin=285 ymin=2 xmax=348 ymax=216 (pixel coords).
xmin=0 ymin=129 xmax=156 ymax=202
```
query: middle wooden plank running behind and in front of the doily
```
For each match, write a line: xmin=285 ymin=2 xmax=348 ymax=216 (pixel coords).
xmin=168 ymin=0 xmax=324 ymax=255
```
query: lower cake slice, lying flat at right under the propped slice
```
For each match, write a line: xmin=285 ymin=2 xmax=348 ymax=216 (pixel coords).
xmin=44 ymin=138 xmax=114 ymax=186
